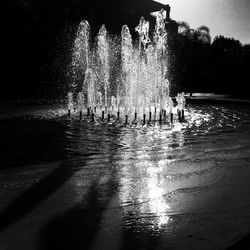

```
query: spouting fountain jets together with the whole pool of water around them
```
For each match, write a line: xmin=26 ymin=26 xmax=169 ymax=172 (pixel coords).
xmin=3 ymin=7 xmax=250 ymax=250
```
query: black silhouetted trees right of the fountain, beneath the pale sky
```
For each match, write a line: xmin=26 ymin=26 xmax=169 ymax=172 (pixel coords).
xmin=168 ymin=21 xmax=250 ymax=97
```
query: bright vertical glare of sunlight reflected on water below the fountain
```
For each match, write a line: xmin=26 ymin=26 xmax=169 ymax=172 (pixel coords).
xmin=119 ymin=128 xmax=184 ymax=230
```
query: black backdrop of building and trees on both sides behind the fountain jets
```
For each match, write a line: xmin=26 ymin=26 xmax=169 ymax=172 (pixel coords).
xmin=0 ymin=0 xmax=250 ymax=102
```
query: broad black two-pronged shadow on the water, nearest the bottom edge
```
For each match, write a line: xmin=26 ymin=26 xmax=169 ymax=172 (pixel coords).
xmin=39 ymin=172 xmax=118 ymax=250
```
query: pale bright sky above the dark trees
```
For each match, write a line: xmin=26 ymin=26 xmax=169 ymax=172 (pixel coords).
xmin=156 ymin=0 xmax=250 ymax=44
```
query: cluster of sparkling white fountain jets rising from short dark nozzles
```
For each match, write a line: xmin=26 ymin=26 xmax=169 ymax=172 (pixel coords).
xmin=68 ymin=9 xmax=185 ymax=125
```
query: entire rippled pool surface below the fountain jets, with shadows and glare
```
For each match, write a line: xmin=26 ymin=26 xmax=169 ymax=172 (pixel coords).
xmin=0 ymin=103 xmax=250 ymax=250
